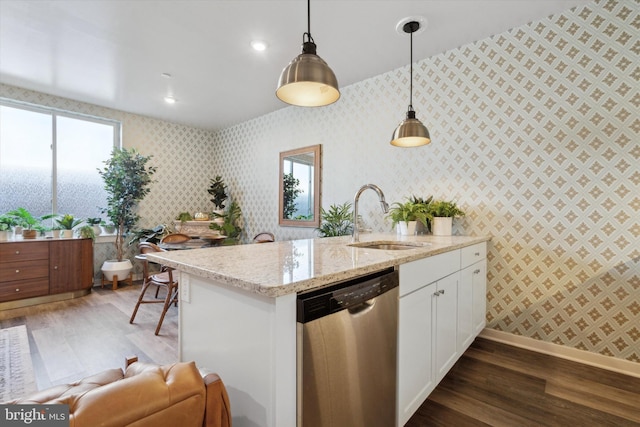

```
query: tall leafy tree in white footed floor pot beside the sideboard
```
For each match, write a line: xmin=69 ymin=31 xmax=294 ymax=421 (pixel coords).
xmin=98 ymin=148 xmax=156 ymax=281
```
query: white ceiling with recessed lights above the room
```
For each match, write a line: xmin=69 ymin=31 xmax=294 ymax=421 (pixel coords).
xmin=0 ymin=0 xmax=589 ymax=130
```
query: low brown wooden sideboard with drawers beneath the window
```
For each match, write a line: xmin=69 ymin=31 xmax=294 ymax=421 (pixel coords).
xmin=0 ymin=239 xmax=93 ymax=309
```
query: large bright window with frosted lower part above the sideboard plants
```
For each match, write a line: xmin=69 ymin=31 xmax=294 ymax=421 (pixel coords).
xmin=0 ymin=99 xmax=120 ymax=224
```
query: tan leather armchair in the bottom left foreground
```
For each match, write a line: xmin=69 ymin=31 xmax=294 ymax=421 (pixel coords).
xmin=4 ymin=362 xmax=231 ymax=427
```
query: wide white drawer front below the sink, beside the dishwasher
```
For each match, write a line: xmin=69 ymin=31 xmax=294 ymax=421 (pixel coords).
xmin=400 ymin=250 xmax=460 ymax=296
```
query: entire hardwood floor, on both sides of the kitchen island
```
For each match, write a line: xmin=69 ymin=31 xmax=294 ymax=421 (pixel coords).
xmin=0 ymin=284 xmax=640 ymax=427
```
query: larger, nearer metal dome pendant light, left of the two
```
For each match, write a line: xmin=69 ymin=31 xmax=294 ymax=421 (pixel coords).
xmin=276 ymin=0 xmax=340 ymax=107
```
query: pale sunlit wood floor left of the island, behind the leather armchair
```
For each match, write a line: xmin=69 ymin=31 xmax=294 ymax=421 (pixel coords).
xmin=0 ymin=282 xmax=178 ymax=390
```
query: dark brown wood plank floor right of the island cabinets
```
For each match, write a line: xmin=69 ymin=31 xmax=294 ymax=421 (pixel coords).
xmin=406 ymin=338 xmax=640 ymax=427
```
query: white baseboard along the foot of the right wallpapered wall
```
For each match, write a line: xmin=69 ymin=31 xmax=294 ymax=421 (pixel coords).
xmin=478 ymin=328 xmax=640 ymax=378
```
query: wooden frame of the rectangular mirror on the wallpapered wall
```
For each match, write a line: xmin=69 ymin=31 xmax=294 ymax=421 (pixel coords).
xmin=278 ymin=144 xmax=322 ymax=227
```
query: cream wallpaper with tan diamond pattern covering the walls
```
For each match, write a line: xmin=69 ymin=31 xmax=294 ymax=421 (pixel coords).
xmin=0 ymin=0 xmax=640 ymax=363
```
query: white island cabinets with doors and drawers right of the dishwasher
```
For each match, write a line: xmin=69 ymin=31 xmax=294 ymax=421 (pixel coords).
xmin=397 ymin=243 xmax=486 ymax=426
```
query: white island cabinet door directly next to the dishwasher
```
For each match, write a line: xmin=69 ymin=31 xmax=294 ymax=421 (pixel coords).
xmin=397 ymin=282 xmax=436 ymax=426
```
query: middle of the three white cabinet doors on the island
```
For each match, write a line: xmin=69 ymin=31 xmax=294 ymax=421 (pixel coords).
xmin=433 ymin=273 xmax=460 ymax=383
